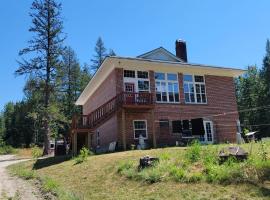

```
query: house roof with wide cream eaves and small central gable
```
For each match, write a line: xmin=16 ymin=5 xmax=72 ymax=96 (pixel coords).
xmin=75 ymin=47 xmax=245 ymax=105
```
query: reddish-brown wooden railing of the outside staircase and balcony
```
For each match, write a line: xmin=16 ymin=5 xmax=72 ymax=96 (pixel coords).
xmin=72 ymin=92 xmax=153 ymax=129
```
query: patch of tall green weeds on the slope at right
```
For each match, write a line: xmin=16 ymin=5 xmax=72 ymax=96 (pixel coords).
xmin=117 ymin=142 xmax=270 ymax=184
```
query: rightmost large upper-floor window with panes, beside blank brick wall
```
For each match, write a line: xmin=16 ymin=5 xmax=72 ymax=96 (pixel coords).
xmin=184 ymin=74 xmax=206 ymax=103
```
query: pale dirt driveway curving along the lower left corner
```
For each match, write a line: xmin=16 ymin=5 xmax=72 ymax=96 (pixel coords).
xmin=0 ymin=155 xmax=43 ymax=200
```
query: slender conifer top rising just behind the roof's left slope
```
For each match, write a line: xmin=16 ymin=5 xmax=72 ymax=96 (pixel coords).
xmin=91 ymin=37 xmax=107 ymax=72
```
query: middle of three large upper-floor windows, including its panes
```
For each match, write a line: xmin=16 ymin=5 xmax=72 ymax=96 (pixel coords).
xmin=155 ymin=72 xmax=179 ymax=103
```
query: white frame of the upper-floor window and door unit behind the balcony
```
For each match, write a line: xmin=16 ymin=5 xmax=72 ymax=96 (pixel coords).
xmin=123 ymin=69 xmax=151 ymax=92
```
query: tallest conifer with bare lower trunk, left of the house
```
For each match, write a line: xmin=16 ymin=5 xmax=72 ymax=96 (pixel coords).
xmin=16 ymin=0 xmax=65 ymax=154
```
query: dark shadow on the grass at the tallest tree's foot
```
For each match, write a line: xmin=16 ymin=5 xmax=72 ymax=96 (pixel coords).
xmin=33 ymin=155 xmax=72 ymax=169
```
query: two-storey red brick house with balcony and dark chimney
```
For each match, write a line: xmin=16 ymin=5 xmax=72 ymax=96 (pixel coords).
xmin=71 ymin=40 xmax=244 ymax=153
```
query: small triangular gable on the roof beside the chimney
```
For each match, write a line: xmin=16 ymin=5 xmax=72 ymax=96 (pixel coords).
xmin=137 ymin=47 xmax=184 ymax=63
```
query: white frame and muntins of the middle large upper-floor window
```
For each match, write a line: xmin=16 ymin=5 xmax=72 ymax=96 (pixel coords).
xmin=154 ymin=72 xmax=180 ymax=104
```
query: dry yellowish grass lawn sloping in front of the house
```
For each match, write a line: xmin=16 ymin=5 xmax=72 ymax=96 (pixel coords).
xmin=7 ymin=144 xmax=270 ymax=200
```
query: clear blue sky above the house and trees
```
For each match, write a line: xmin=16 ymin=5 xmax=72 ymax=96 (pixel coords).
xmin=0 ymin=0 xmax=270 ymax=110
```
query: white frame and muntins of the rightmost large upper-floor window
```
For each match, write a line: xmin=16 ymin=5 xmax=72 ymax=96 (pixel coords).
xmin=183 ymin=74 xmax=207 ymax=104
